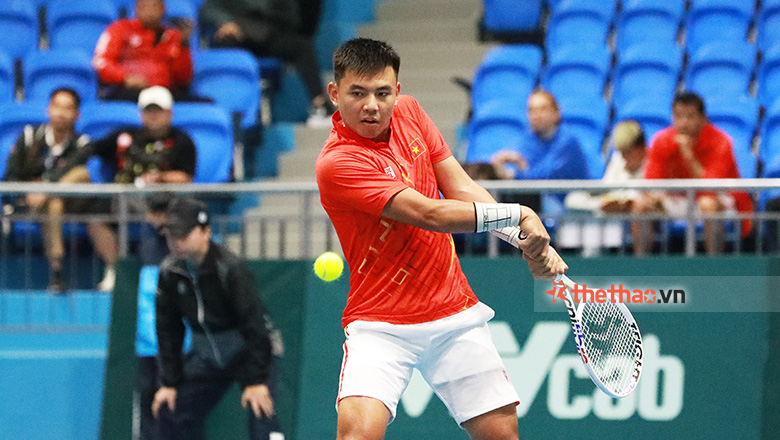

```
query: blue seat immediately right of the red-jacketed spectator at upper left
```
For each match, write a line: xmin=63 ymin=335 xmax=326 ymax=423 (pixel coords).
xmin=192 ymin=49 xmax=260 ymax=127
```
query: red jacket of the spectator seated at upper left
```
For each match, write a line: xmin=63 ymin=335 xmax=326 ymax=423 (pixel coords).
xmin=92 ymin=19 xmax=192 ymax=88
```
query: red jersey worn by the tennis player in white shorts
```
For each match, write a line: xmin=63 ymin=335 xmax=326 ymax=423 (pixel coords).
xmin=317 ymin=95 xmax=477 ymax=327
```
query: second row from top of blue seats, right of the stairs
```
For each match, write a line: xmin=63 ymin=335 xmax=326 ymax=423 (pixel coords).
xmin=472 ymin=41 xmax=780 ymax=115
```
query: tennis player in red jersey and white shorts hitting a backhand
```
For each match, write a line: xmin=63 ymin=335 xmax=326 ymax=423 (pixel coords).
xmin=317 ymin=39 xmax=567 ymax=440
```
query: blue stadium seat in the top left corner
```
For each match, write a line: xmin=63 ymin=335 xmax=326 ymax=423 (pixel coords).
xmin=0 ymin=0 xmax=38 ymax=58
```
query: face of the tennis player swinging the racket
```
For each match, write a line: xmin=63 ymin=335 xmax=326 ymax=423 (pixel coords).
xmin=328 ymin=66 xmax=401 ymax=140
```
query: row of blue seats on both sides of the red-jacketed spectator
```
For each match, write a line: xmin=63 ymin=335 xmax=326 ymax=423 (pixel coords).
xmin=0 ymin=49 xmax=261 ymax=126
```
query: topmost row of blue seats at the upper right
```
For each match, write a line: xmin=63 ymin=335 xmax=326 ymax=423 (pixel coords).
xmin=484 ymin=0 xmax=780 ymax=51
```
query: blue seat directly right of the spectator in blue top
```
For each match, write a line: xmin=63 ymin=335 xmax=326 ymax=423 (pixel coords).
xmin=559 ymin=96 xmax=609 ymax=179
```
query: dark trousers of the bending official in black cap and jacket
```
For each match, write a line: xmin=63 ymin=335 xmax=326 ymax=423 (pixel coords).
xmin=155 ymin=357 xmax=281 ymax=440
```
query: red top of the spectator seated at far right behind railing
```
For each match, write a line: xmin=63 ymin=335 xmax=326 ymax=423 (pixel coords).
xmin=645 ymin=123 xmax=753 ymax=235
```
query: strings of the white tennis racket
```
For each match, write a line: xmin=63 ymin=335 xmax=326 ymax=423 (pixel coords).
xmin=582 ymin=302 xmax=635 ymax=393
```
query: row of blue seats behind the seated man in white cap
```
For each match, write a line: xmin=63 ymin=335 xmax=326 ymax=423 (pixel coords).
xmin=0 ymin=101 xmax=234 ymax=183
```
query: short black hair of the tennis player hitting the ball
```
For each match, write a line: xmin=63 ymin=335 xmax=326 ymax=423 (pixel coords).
xmin=333 ymin=38 xmax=401 ymax=83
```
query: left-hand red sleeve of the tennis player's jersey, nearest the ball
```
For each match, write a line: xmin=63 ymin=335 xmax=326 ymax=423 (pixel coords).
xmin=317 ymin=148 xmax=408 ymax=216
